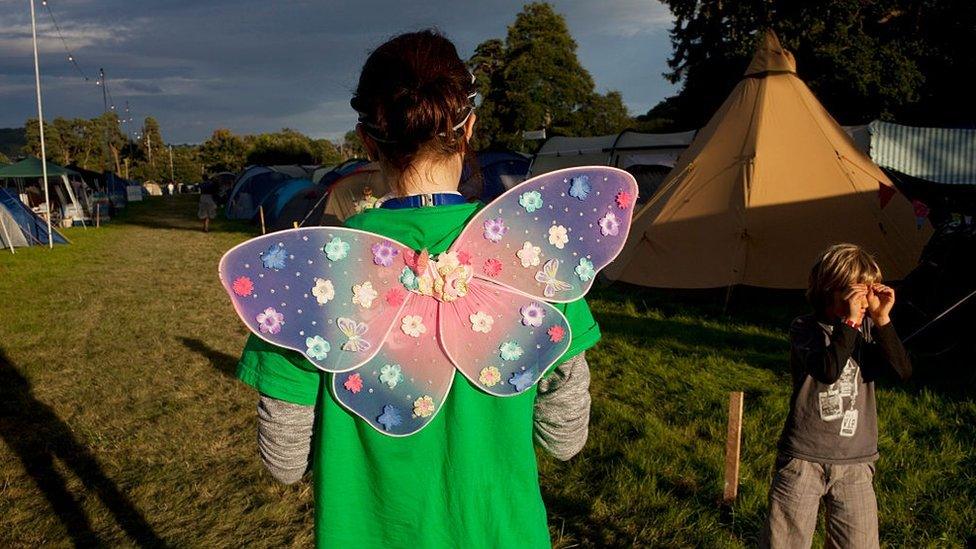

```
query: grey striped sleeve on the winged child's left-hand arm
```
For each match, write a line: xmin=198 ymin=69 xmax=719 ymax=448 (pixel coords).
xmin=258 ymin=395 xmax=315 ymax=484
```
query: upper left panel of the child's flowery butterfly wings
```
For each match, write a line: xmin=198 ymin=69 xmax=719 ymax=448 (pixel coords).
xmin=219 ymin=227 xmax=409 ymax=372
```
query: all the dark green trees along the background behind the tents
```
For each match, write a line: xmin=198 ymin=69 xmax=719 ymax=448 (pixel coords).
xmin=11 ymin=0 xmax=976 ymax=181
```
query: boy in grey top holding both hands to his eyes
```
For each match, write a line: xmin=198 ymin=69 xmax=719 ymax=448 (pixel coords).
xmin=763 ymin=244 xmax=912 ymax=548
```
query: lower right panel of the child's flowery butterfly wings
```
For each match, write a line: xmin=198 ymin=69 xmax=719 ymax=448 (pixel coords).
xmin=439 ymin=279 xmax=570 ymax=396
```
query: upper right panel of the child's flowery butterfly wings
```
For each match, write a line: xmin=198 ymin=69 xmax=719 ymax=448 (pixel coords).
xmin=451 ymin=166 xmax=637 ymax=303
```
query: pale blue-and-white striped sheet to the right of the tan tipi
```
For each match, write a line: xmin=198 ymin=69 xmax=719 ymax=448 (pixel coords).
xmin=868 ymin=120 xmax=976 ymax=184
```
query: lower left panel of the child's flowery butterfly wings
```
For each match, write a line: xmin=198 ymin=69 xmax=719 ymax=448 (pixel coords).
xmin=332 ymin=294 xmax=454 ymax=436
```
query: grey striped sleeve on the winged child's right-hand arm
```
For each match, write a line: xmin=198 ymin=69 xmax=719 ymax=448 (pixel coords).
xmin=533 ymin=353 xmax=590 ymax=461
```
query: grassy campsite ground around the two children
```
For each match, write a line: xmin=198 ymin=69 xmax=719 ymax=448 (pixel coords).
xmin=0 ymin=197 xmax=976 ymax=547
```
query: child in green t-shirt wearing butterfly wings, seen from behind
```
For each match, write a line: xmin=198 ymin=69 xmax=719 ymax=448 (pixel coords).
xmin=221 ymin=31 xmax=637 ymax=548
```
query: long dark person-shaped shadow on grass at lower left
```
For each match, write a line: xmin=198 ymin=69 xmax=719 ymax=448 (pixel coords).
xmin=0 ymin=349 xmax=165 ymax=547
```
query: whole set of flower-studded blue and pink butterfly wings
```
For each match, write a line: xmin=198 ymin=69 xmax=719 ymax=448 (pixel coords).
xmin=219 ymin=167 xmax=637 ymax=436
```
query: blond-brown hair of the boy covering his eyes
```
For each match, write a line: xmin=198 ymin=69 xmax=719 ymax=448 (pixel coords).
xmin=807 ymin=244 xmax=881 ymax=312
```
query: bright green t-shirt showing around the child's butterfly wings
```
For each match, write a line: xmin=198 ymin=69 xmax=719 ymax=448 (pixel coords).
xmin=237 ymin=204 xmax=600 ymax=548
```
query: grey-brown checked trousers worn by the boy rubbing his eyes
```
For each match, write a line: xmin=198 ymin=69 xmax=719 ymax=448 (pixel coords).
xmin=761 ymin=456 xmax=879 ymax=549
